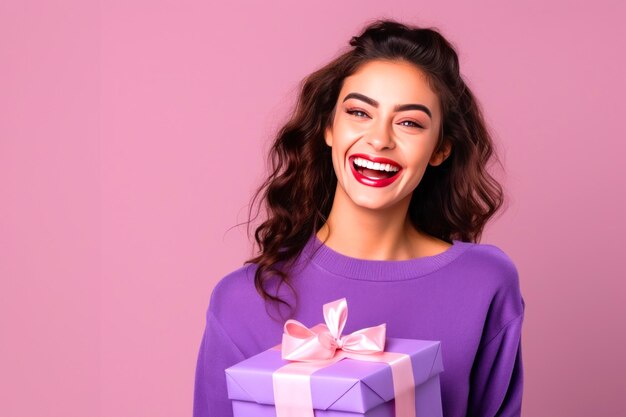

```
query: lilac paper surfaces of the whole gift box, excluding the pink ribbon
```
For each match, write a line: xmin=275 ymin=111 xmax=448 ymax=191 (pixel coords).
xmin=225 ymin=337 xmax=443 ymax=417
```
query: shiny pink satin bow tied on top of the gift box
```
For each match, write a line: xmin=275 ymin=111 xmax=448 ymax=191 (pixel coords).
xmin=282 ymin=298 xmax=386 ymax=362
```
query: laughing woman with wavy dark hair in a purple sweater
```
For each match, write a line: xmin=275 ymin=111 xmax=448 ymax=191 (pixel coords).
xmin=194 ymin=20 xmax=524 ymax=417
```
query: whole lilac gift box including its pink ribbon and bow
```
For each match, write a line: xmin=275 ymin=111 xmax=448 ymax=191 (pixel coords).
xmin=225 ymin=299 xmax=443 ymax=417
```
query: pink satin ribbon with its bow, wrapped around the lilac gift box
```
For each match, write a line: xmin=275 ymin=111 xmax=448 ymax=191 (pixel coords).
xmin=272 ymin=298 xmax=415 ymax=417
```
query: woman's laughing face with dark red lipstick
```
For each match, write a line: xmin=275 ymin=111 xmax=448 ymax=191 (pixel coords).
xmin=325 ymin=61 xmax=449 ymax=209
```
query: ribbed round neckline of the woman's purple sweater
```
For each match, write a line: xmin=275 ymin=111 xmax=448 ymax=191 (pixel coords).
xmin=302 ymin=232 xmax=474 ymax=281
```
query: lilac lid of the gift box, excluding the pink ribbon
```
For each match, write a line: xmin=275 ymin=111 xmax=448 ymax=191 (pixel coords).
xmin=225 ymin=337 xmax=443 ymax=413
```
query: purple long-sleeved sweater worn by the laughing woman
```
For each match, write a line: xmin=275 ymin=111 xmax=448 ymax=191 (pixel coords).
xmin=193 ymin=234 xmax=524 ymax=417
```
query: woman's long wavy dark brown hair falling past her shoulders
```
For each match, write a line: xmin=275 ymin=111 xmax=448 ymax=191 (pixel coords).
xmin=236 ymin=19 xmax=503 ymax=320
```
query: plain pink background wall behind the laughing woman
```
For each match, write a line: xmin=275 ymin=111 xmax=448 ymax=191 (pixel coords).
xmin=0 ymin=0 xmax=626 ymax=417
